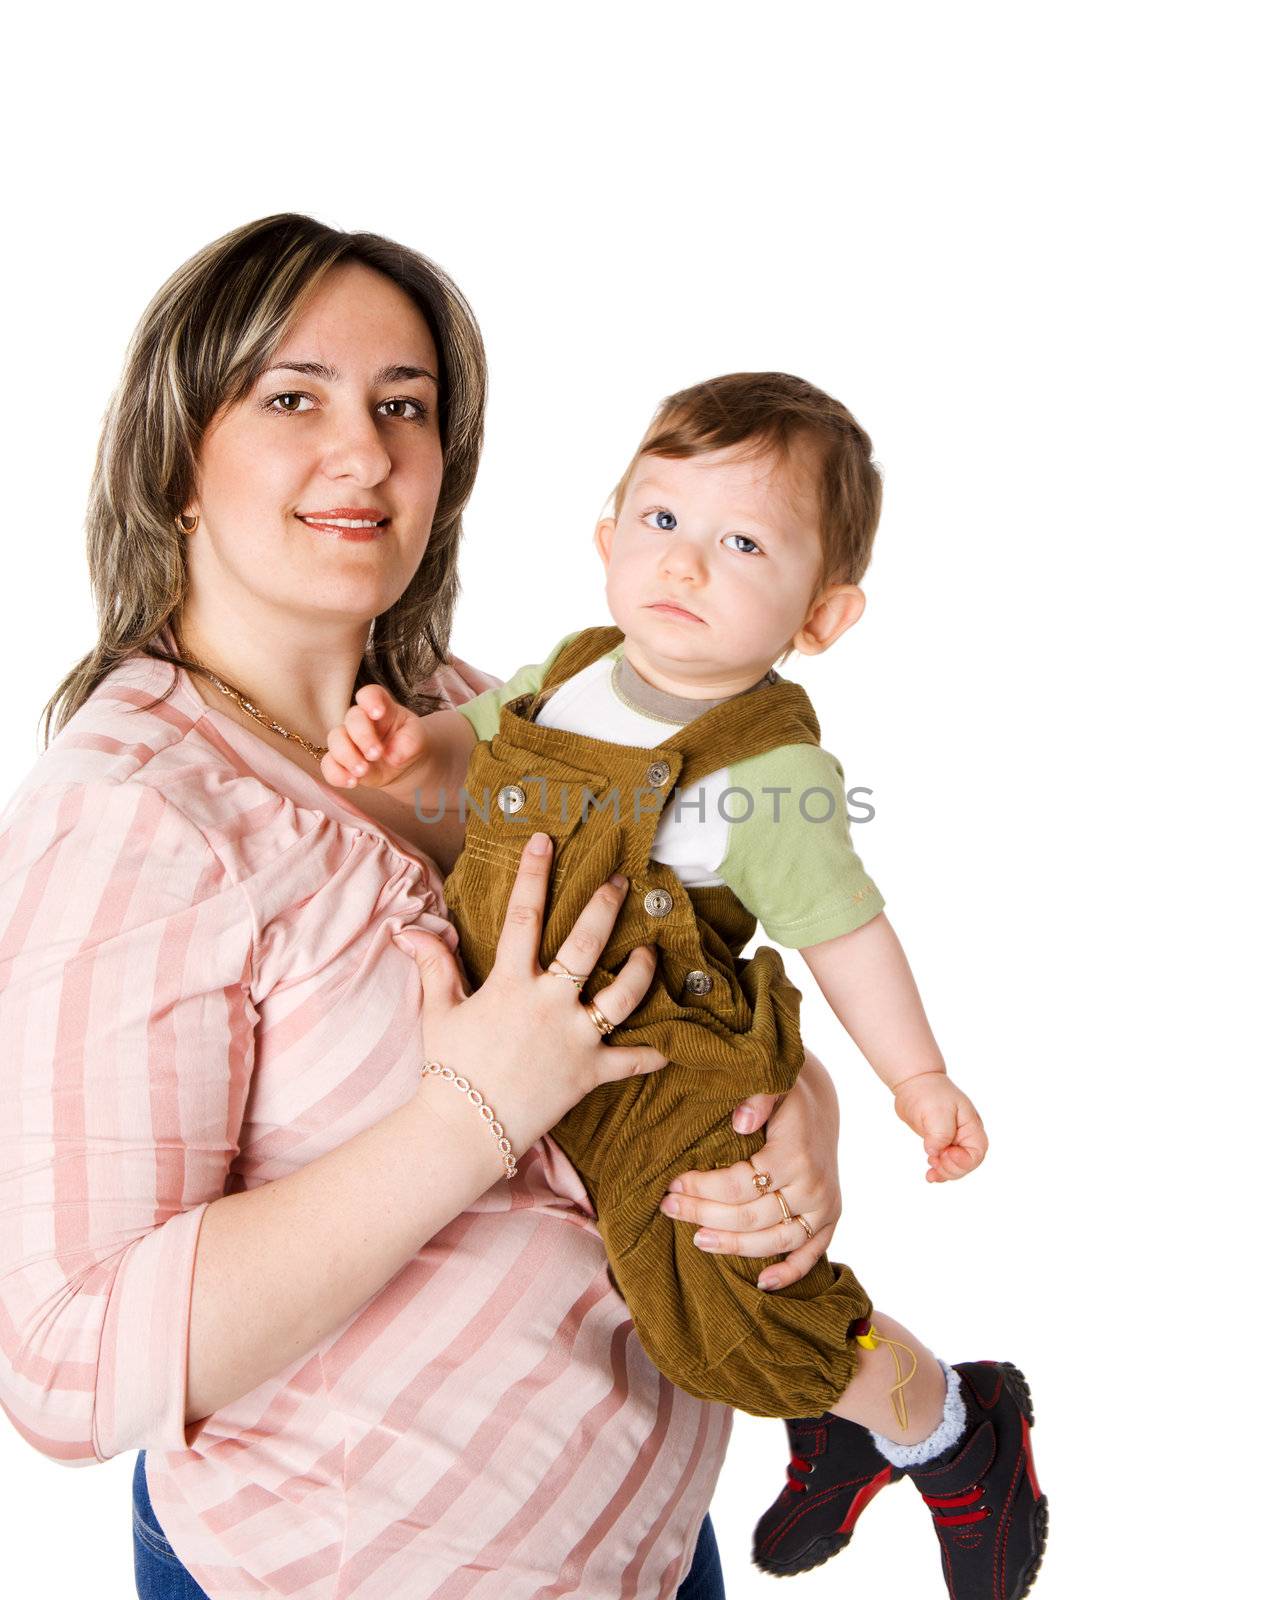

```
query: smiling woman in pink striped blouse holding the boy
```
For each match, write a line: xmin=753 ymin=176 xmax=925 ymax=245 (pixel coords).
xmin=0 ymin=214 xmax=857 ymax=1600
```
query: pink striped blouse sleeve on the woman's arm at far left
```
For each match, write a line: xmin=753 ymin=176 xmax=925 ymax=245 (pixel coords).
xmin=0 ymin=781 xmax=256 ymax=1466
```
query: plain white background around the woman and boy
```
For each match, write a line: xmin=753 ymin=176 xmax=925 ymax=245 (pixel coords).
xmin=0 ymin=0 xmax=1279 ymax=1600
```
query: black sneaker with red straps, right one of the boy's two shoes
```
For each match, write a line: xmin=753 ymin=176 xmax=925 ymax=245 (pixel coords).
xmin=907 ymin=1362 xmax=1047 ymax=1600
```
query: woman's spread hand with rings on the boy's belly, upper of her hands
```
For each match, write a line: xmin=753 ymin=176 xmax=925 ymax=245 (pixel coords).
xmin=397 ymin=834 xmax=667 ymax=1157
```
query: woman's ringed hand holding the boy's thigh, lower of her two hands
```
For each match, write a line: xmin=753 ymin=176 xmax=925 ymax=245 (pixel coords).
xmin=661 ymin=1050 xmax=842 ymax=1290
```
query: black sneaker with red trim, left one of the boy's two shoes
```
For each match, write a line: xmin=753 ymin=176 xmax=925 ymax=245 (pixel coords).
xmin=752 ymin=1411 xmax=904 ymax=1578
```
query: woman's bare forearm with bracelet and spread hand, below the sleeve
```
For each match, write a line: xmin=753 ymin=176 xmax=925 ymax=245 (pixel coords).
xmin=187 ymin=835 xmax=664 ymax=1421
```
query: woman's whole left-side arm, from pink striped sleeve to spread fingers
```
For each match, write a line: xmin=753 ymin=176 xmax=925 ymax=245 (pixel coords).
xmin=0 ymin=782 xmax=663 ymax=1464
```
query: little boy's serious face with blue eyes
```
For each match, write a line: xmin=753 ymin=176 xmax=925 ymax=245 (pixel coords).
xmin=597 ymin=448 xmax=863 ymax=694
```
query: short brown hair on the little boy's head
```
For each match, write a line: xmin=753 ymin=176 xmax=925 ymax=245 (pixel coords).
xmin=615 ymin=373 xmax=882 ymax=592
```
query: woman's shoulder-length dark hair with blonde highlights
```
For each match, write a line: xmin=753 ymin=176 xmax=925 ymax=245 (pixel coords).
xmin=43 ymin=211 xmax=487 ymax=744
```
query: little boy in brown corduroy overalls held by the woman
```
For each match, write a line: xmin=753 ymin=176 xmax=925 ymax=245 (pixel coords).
xmin=322 ymin=373 xmax=1047 ymax=1600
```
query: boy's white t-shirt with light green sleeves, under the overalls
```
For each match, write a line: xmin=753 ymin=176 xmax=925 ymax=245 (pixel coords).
xmin=458 ymin=630 xmax=885 ymax=949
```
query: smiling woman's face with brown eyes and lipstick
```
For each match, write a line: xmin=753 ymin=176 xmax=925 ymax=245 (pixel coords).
xmin=186 ymin=262 xmax=442 ymax=629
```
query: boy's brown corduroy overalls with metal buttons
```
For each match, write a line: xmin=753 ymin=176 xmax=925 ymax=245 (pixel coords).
xmin=445 ymin=627 xmax=872 ymax=1416
